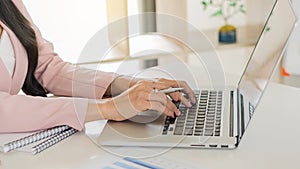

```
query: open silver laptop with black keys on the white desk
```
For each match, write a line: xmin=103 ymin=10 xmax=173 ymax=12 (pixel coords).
xmin=95 ymin=0 xmax=297 ymax=149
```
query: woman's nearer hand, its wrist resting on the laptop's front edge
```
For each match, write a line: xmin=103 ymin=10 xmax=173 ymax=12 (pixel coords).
xmin=99 ymin=80 xmax=180 ymax=121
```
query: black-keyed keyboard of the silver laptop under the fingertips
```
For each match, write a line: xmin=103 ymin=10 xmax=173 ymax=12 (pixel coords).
xmin=162 ymin=90 xmax=223 ymax=136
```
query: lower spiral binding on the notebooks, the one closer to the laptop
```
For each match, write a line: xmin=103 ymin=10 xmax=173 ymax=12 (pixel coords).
xmin=31 ymin=128 xmax=78 ymax=154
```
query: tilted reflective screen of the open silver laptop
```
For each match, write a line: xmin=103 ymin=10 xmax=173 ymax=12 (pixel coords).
xmin=238 ymin=0 xmax=297 ymax=108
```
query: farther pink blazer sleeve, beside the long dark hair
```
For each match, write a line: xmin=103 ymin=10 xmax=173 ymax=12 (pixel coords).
xmin=15 ymin=0 xmax=117 ymax=99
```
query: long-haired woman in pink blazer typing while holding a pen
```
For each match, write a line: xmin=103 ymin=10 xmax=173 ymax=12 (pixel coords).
xmin=0 ymin=0 xmax=195 ymax=133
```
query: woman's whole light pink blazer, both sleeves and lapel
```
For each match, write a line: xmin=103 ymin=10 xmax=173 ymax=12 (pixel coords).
xmin=0 ymin=0 xmax=116 ymax=133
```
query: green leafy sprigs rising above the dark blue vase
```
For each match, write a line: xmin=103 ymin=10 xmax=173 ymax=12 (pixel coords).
xmin=202 ymin=0 xmax=246 ymax=24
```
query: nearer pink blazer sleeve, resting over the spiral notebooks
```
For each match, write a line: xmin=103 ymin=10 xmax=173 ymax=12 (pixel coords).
xmin=0 ymin=92 xmax=88 ymax=133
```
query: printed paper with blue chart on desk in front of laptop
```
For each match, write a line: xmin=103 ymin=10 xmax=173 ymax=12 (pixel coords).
xmin=75 ymin=147 xmax=205 ymax=169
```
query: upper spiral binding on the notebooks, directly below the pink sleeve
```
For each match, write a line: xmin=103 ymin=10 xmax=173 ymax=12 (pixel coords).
xmin=3 ymin=125 xmax=70 ymax=153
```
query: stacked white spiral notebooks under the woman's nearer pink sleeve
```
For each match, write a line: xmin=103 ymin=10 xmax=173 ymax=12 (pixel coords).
xmin=0 ymin=125 xmax=77 ymax=154
